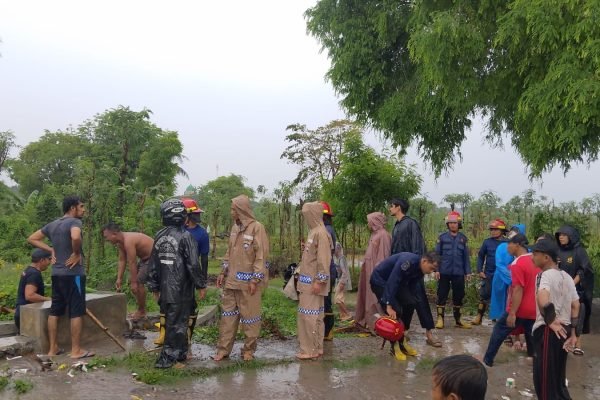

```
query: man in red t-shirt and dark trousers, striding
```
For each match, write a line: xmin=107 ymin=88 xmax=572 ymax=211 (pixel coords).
xmin=483 ymin=234 xmax=540 ymax=367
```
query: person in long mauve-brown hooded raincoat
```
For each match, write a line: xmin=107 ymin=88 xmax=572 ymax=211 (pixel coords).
xmin=354 ymin=212 xmax=392 ymax=330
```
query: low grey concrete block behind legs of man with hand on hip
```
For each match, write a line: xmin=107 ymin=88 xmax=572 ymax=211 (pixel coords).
xmin=21 ymin=292 xmax=128 ymax=353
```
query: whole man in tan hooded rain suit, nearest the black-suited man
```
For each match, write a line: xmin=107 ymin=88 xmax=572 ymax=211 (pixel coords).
xmin=213 ymin=195 xmax=269 ymax=361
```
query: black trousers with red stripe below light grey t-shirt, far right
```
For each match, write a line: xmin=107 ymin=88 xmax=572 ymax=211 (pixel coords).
xmin=533 ymin=325 xmax=571 ymax=400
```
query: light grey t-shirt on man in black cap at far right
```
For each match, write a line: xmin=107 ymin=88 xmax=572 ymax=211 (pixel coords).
xmin=533 ymin=268 xmax=579 ymax=331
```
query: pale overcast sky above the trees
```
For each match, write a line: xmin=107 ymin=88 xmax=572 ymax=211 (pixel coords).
xmin=0 ymin=0 xmax=600 ymax=206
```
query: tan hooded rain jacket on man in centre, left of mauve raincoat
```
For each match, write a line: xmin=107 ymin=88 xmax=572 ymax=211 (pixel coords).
xmin=298 ymin=201 xmax=333 ymax=296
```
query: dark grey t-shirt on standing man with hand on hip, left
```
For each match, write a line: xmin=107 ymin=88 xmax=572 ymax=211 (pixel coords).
xmin=42 ymin=217 xmax=85 ymax=276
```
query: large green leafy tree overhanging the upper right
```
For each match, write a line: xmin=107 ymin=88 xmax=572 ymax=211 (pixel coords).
xmin=306 ymin=0 xmax=600 ymax=176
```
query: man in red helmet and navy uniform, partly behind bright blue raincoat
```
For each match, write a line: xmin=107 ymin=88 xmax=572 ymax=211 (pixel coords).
xmin=473 ymin=218 xmax=507 ymax=325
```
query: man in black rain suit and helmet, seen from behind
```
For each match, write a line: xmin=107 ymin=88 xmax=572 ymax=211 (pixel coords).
xmin=147 ymin=199 xmax=206 ymax=368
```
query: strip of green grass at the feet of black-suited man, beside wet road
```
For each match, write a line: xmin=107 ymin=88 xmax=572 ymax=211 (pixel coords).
xmin=95 ymin=353 xmax=291 ymax=385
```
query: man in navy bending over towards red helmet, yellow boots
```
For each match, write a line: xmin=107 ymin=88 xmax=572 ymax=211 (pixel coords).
xmin=370 ymin=252 xmax=440 ymax=361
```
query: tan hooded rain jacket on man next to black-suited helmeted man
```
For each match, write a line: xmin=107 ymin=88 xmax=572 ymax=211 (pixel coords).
xmin=224 ymin=195 xmax=269 ymax=289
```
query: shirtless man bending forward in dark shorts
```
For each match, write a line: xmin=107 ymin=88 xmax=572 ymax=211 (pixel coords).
xmin=102 ymin=222 xmax=154 ymax=320
